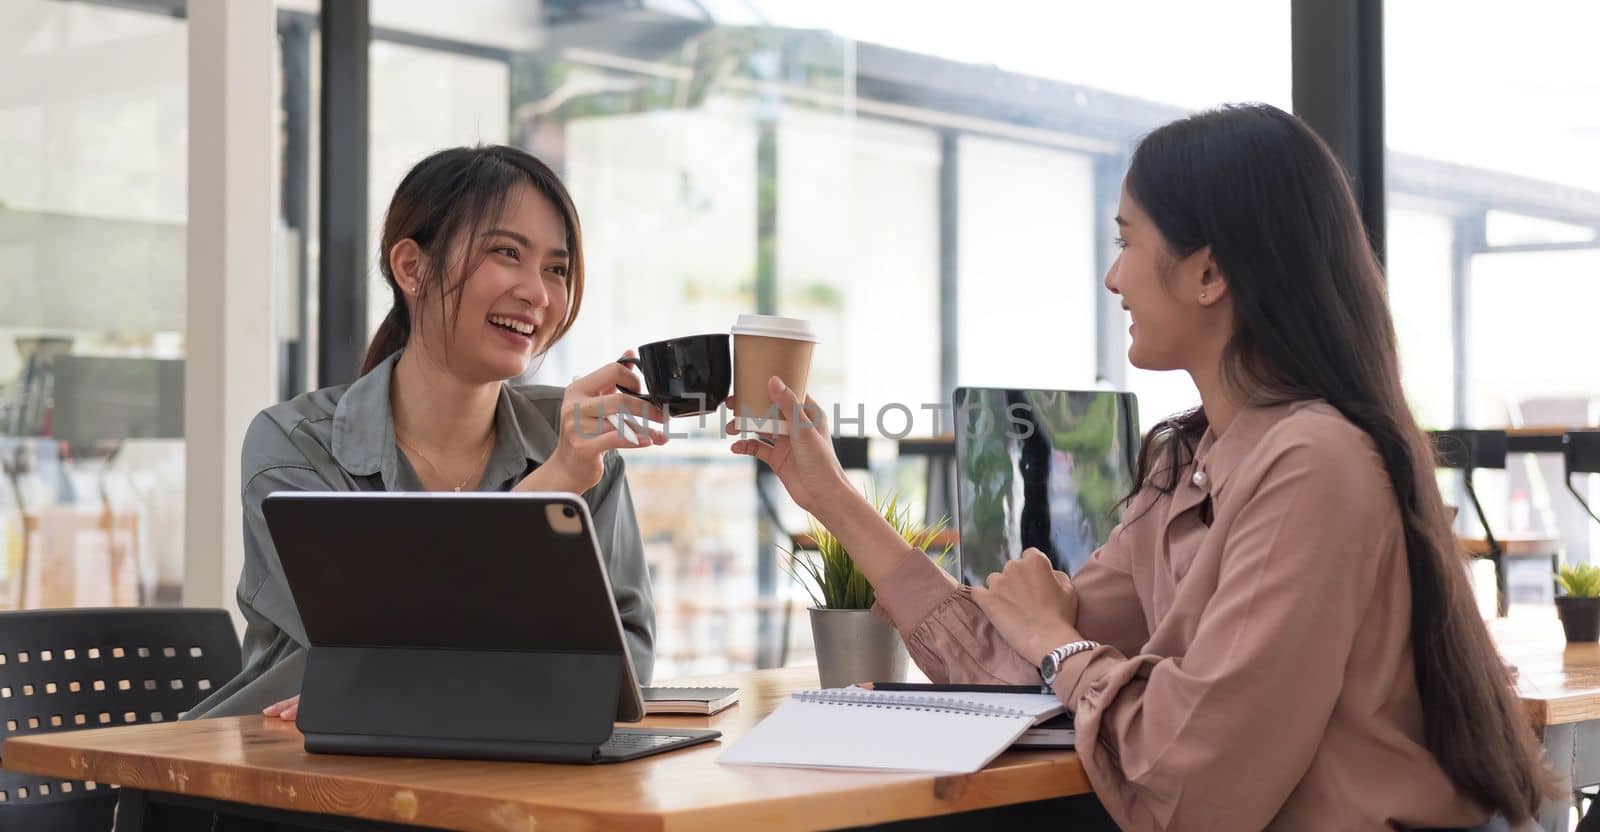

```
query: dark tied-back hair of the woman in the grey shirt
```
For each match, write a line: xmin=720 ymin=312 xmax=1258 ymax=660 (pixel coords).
xmin=362 ymin=144 xmax=584 ymax=376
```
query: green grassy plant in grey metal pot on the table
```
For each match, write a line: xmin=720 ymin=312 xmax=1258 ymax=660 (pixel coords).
xmin=789 ymin=496 xmax=950 ymax=688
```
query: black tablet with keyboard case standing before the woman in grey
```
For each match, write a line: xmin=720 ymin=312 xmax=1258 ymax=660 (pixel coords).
xmin=262 ymin=491 xmax=720 ymax=763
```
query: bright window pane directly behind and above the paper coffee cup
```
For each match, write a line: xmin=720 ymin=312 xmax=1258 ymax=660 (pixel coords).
xmin=776 ymin=109 xmax=941 ymax=435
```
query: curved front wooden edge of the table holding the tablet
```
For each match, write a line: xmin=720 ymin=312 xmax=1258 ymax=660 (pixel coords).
xmin=0 ymin=728 xmax=1093 ymax=832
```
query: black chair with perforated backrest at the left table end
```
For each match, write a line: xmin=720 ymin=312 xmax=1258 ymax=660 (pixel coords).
xmin=0 ymin=608 xmax=240 ymax=832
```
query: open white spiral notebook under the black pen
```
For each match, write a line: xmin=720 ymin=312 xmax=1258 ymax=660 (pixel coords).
xmin=717 ymin=688 xmax=1066 ymax=774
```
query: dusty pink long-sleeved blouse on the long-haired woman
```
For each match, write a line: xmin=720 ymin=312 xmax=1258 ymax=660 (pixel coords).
xmin=877 ymin=402 xmax=1488 ymax=830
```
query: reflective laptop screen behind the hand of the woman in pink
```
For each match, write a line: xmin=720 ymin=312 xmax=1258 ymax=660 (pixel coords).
xmin=955 ymin=387 xmax=1139 ymax=586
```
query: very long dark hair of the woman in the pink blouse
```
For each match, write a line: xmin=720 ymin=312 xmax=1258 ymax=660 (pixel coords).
xmin=1126 ymin=104 xmax=1552 ymax=821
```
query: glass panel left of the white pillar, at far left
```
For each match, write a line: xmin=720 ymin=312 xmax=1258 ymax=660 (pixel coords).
xmin=0 ymin=0 xmax=187 ymax=608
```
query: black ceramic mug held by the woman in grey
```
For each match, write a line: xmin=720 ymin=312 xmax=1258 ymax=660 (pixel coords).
xmin=618 ymin=333 xmax=733 ymax=416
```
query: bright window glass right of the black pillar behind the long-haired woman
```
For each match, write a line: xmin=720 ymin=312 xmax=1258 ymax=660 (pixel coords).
xmin=1384 ymin=0 xmax=1600 ymax=566
